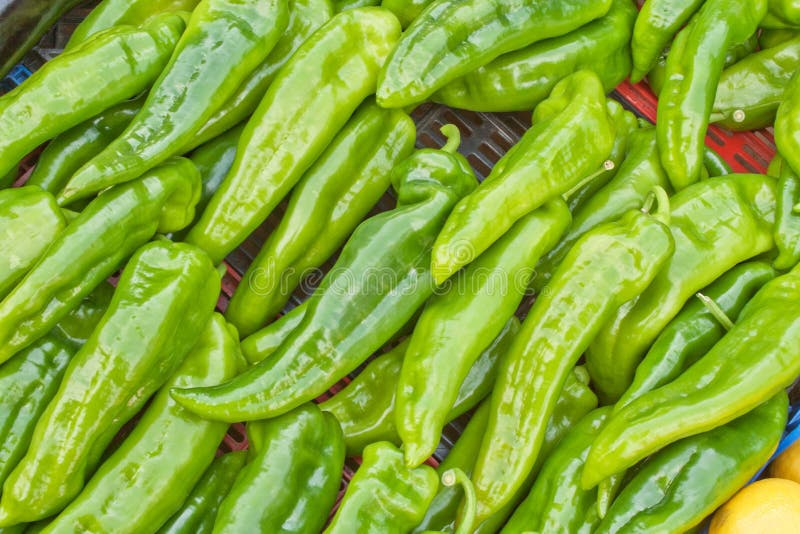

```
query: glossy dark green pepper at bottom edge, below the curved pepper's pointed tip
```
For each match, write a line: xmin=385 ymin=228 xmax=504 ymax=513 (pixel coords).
xmin=214 ymin=403 xmax=344 ymax=534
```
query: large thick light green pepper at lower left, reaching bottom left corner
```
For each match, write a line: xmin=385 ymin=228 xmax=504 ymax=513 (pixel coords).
xmin=0 ymin=241 xmax=219 ymax=526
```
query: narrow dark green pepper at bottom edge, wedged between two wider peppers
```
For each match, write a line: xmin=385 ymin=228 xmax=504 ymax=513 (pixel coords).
xmin=158 ymin=451 xmax=247 ymax=534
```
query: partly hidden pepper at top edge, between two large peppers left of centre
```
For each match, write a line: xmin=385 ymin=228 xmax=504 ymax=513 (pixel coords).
xmin=184 ymin=0 xmax=333 ymax=154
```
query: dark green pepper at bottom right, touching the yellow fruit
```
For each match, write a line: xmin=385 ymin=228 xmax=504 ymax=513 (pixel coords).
xmin=595 ymin=392 xmax=788 ymax=534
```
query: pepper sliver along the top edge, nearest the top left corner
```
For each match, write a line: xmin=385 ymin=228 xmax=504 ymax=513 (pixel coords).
xmin=64 ymin=0 xmax=199 ymax=52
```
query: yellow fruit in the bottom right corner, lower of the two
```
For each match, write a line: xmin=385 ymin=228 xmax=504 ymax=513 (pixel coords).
xmin=708 ymin=478 xmax=800 ymax=534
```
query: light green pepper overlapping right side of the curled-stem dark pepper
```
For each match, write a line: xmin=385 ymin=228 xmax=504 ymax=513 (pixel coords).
xmin=431 ymin=71 xmax=614 ymax=284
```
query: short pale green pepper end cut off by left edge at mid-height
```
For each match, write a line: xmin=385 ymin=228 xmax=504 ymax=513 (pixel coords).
xmin=0 ymin=186 xmax=66 ymax=298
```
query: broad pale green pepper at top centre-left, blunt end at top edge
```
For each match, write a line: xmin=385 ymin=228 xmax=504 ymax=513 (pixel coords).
xmin=187 ymin=7 xmax=400 ymax=262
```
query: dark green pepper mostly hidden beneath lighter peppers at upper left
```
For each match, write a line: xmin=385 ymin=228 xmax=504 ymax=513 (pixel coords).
xmin=26 ymin=97 xmax=144 ymax=195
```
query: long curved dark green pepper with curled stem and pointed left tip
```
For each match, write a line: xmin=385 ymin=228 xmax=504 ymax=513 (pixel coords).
xmin=173 ymin=126 xmax=476 ymax=422
